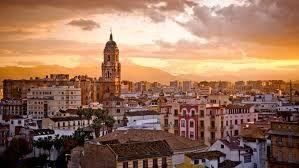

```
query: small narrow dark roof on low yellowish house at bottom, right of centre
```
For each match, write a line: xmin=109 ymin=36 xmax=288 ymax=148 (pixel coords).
xmin=186 ymin=151 xmax=225 ymax=160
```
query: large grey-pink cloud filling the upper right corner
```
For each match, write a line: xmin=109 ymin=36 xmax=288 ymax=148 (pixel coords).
xmin=178 ymin=0 xmax=299 ymax=59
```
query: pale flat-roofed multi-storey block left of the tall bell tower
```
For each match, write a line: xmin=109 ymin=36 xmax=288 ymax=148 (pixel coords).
xmin=27 ymin=86 xmax=81 ymax=119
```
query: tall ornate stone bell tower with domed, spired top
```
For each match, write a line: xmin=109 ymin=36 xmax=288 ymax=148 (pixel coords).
xmin=97 ymin=33 xmax=121 ymax=102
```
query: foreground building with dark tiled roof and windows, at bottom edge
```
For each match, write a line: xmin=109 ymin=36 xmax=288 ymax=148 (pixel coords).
xmin=81 ymin=140 xmax=173 ymax=168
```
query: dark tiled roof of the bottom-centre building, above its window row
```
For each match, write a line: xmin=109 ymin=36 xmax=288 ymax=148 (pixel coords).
xmin=108 ymin=141 xmax=172 ymax=161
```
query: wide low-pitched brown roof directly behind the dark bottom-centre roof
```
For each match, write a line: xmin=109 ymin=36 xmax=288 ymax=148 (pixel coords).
xmin=97 ymin=129 xmax=206 ymax=152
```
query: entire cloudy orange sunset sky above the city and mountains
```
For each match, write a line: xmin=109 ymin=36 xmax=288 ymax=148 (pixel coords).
xmin=0 ymin=0 xmax=299 ymax=79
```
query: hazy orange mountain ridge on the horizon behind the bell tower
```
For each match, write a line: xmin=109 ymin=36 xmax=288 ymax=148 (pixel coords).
xmin=0 ymin=65 xmax=184 ymax=84
